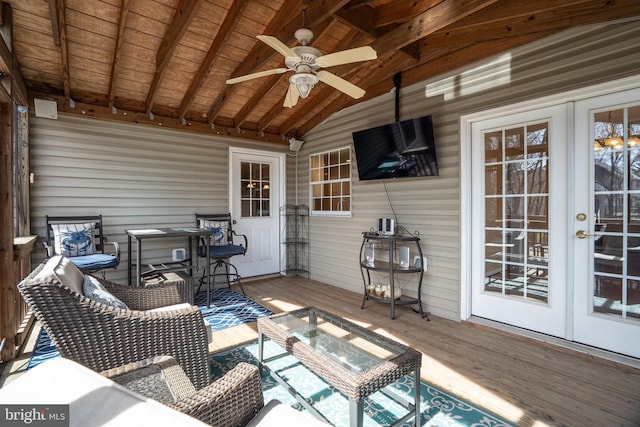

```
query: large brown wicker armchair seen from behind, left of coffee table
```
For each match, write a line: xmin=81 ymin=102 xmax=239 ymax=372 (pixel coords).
xmin=18 ymin=257 xmax=211 ymax=389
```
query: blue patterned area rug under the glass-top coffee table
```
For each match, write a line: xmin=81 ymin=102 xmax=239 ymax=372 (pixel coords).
xmin=211 ymin=341 xmax=515 ymax=427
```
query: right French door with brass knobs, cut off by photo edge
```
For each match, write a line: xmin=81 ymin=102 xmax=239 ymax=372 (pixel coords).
xmin=572 ymin=89 xmax=640 ymax=357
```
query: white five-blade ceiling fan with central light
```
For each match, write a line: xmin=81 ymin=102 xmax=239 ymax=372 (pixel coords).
xmin=227 ymin=28 xmax=378 ymax=108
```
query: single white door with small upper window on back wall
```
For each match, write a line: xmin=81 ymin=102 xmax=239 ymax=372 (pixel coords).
xmin=229 ymin=148 xmax=285 ymax=277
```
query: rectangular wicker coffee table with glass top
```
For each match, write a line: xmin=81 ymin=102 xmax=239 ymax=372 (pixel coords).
xmin=258 ymin=307 xmax=422 ymax=427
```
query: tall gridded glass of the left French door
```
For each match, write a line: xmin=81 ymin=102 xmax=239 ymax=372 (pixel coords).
xmin=484 ymin=122 xmax=549 ymax=303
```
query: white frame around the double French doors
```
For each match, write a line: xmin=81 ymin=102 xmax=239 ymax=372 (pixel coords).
xmin=459 ymin=75 xmax=640 ymax=324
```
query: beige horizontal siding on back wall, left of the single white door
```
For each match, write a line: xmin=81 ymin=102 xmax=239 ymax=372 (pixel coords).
xmin=30 ymin=115 xmax=285 ymax=283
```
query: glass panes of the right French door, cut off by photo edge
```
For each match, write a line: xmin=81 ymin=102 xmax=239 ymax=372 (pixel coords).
xmin=591 ymin=106 xmax=640 ymax=321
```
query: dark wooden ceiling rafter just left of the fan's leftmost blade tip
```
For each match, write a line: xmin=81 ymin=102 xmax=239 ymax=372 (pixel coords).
xmin=178 ymin=0 xmax=252 ymax=119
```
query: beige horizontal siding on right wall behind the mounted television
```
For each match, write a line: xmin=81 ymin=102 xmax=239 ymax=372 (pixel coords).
xmin=298 ymin=19 xmax=640 ymax=320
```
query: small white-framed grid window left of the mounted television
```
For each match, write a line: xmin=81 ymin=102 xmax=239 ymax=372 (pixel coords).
xmin=309 ymin=147 xmax=351 ymax=216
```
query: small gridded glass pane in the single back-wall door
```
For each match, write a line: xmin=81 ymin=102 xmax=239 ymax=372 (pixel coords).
xmin=240 ymin=162 xmax=271 ymax=218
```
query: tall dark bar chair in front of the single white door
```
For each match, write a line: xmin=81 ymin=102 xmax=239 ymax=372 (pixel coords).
xmin=196 ymin=213 xmax=248 ymax=303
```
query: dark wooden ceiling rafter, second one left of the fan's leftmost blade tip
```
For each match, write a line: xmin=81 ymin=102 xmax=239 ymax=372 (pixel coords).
xmin=145 ymin=0 xmax=204 ymax=114
